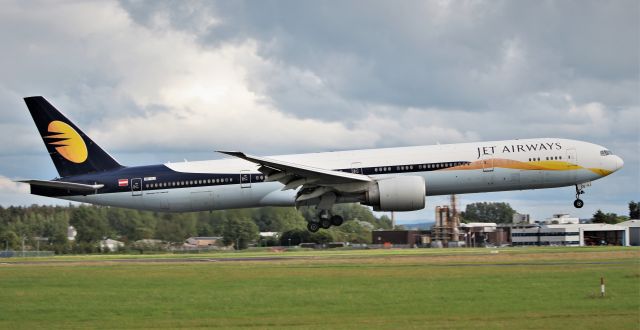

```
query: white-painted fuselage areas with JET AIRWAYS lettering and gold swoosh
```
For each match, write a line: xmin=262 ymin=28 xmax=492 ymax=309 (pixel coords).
xmin=63 ymin=138 xmax=622 ymax=212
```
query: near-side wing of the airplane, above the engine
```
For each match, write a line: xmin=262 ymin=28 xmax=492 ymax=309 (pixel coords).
xmin=218 ymin=151 xmax=373 ymax=190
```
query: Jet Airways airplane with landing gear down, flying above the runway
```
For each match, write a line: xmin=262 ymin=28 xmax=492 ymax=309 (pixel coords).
xmin=19 ymin=96 xmax=624 ymax=232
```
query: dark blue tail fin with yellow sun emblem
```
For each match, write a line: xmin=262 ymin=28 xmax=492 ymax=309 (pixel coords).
xmin=24 ymin=96 xmax=122 ymax=177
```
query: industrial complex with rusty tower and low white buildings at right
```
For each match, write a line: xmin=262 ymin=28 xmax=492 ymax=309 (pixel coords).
xmin=372 ymin=195 xmax=640 ymax=248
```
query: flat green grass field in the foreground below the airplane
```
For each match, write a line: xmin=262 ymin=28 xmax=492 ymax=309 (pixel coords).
xmin=0 ymin=247 xmax=640 ymax=329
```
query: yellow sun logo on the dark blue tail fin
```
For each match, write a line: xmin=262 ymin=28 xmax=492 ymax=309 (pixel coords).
xmin=45 ymin=120 xmax=89 ymax=164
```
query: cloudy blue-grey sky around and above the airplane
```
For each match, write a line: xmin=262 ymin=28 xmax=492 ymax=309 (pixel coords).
xmin=0 ymin=0 xmax=640 ymax=222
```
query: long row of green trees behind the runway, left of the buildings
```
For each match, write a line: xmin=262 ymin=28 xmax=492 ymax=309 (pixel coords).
xmin=0 ymin=204 xmax=391 ymax=254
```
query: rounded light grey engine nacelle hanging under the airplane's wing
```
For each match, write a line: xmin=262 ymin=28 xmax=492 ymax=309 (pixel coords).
xmin=364 ymin=176 xmax=427 ymax=211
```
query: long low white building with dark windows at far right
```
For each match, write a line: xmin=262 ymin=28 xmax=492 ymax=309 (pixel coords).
xmin=511 ymin=223 xmax=629 ymax=246
